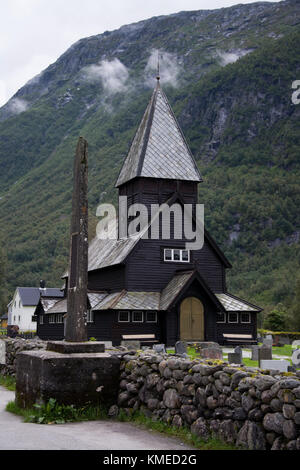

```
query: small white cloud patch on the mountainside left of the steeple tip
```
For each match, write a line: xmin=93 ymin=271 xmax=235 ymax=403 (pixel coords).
xmin=82 ymin=58 xmax=129 ymax=95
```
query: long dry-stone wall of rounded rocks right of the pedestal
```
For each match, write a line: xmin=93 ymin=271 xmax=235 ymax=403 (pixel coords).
xmin=111 ymin=350 xmax=300 ymax=450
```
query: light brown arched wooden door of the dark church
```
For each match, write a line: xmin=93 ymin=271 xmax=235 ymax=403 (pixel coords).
xmin=180 ymin=297 xmax=204 ymax=341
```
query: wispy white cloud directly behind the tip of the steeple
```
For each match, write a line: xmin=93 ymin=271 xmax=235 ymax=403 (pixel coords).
xmin=145 ymin=49 xmax=180 ymax=88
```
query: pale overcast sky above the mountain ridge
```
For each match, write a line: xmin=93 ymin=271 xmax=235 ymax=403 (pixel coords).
xmin=0 ymin=0 xmax=282 ymax=106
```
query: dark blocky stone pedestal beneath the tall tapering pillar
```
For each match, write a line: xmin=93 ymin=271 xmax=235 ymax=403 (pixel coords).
xmin=16 ymin=341 xmax=120 ymax=408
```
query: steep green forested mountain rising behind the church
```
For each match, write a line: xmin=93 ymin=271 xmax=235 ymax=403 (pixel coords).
xmin=0 ymin=0 xmax=300 ymax=324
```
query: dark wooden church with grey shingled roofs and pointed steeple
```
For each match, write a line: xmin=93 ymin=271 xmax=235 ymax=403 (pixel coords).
xmin=36 ymin=79 xmax=261 ymax=346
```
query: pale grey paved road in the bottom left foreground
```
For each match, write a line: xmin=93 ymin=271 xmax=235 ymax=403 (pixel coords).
xmin=0 ymin=387 xmax=195 ymax=450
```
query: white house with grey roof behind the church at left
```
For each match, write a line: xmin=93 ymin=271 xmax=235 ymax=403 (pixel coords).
xmin=8 ymin=287 xmax=63 ymax=332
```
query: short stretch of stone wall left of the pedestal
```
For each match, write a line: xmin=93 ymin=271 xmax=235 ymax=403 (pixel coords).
xmin=0 ymin=336 xmax=47 ymax=377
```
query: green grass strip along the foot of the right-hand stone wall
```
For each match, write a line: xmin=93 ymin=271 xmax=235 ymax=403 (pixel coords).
xmin=118 ymin=410 xmax=237 ymax=450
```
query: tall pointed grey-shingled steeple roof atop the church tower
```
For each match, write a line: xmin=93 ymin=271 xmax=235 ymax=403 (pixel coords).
xmin=116 ymin=80 xmax=202 ymax=187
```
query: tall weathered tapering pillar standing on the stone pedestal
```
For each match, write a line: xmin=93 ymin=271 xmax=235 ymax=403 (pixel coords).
xmin=65 ymin=137 xmax=88 ymax=342
